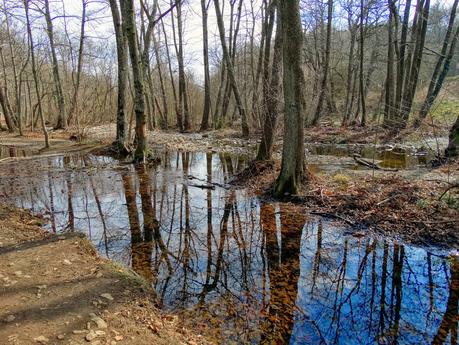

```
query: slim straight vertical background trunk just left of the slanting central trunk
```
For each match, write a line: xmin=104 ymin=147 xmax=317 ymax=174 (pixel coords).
xmin=201 ymin=0 xmax=211 ymax=131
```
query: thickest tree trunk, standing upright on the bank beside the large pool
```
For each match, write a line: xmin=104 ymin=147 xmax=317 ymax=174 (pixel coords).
xmin=274 ymin=0 xmax=306 ymax=196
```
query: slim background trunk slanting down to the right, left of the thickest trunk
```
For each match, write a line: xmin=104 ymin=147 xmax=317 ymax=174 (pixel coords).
xmin=214 ymin=0 xmax=250 ymax=138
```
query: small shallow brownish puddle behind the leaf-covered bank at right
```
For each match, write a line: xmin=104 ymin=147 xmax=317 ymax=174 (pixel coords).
xmin=307 ymin=144 xmax=435 ymax=169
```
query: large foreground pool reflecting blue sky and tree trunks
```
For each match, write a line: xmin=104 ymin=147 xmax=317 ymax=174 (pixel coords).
xmin=0 ymin=152 xmax=459 ymax=344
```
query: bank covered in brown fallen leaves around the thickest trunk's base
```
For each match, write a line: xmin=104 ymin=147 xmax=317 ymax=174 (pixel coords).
xmin=244 ymin=162 xmax=459 ymax=248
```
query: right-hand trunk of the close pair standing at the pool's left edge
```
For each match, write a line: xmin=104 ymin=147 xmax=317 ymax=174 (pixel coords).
xmin=121 ymin=0 xmax=147 ymax=163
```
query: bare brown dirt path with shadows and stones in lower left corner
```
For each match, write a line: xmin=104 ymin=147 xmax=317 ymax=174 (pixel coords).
xmin=0 ymin=206 xmax=205 ymax=345
